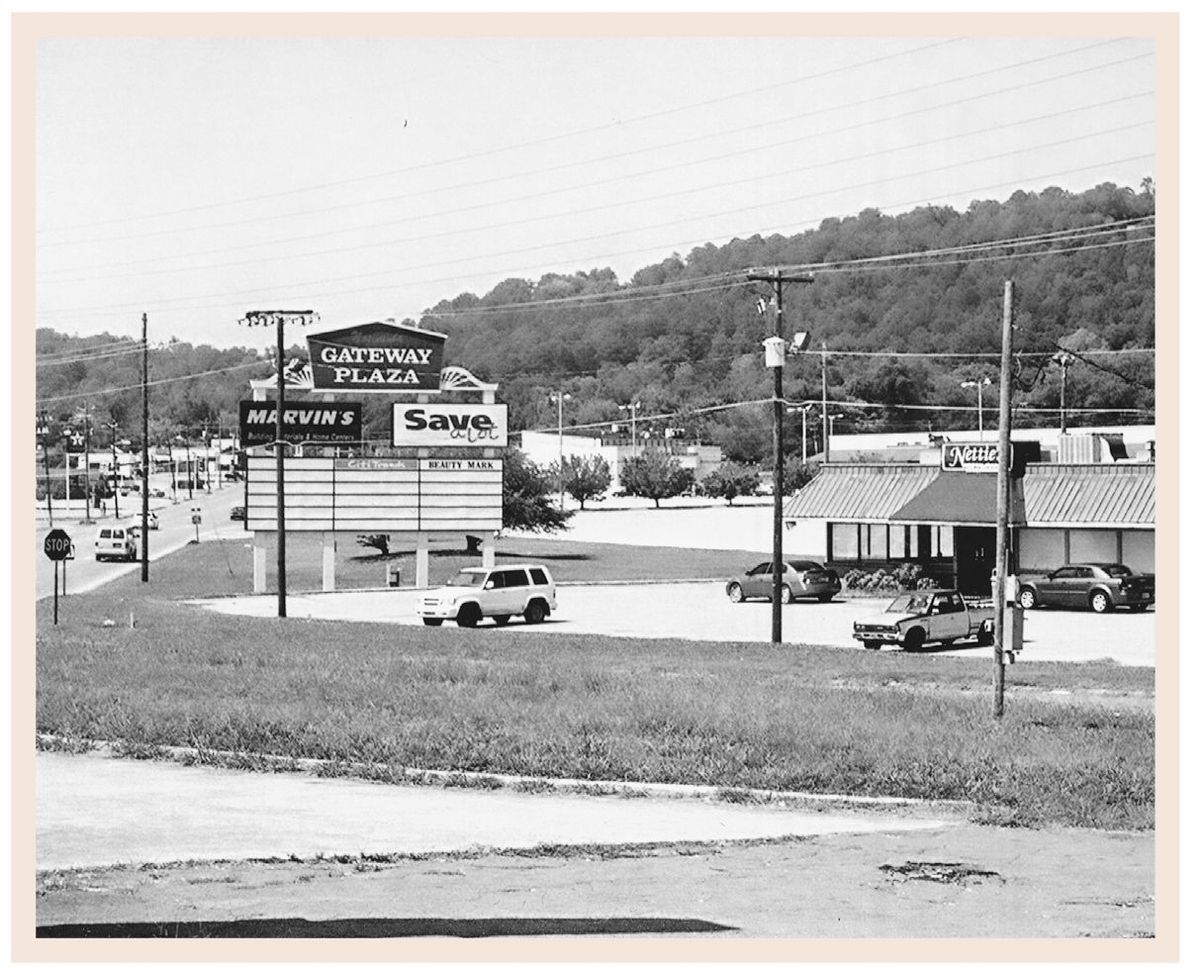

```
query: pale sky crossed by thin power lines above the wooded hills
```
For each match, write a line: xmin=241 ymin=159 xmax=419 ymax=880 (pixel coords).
xmin=36 ymin=20 xmax=1156 ymax=354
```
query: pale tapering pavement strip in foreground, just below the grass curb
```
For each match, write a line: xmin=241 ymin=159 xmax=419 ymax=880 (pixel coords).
xmin=36 ymin=752 xmax=949 ymax=870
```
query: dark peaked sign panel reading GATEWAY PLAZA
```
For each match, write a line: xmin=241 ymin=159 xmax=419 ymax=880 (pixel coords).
xmin=308 ymin=322 xmax=447 ymax=394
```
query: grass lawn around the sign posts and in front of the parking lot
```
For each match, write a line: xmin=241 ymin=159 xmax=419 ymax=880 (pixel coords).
xmin=37 ymin=539 xmax=1155 ymax=829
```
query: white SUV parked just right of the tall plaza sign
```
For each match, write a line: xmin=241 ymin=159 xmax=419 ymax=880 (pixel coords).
xmin=418 ymin=564 xmax=556 ymax=628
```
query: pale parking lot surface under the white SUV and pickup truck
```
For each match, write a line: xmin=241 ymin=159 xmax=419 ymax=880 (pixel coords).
xmin=200 ymin=581 xmax=1157 ymax=666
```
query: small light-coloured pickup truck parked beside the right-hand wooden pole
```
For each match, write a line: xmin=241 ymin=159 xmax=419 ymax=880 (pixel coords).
xmin=852 ymin=590 xmax=995 ymax=651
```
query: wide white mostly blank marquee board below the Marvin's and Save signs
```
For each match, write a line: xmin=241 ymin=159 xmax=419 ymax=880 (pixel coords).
xmin=247 ymin=455 xmax=502 ymax=532
